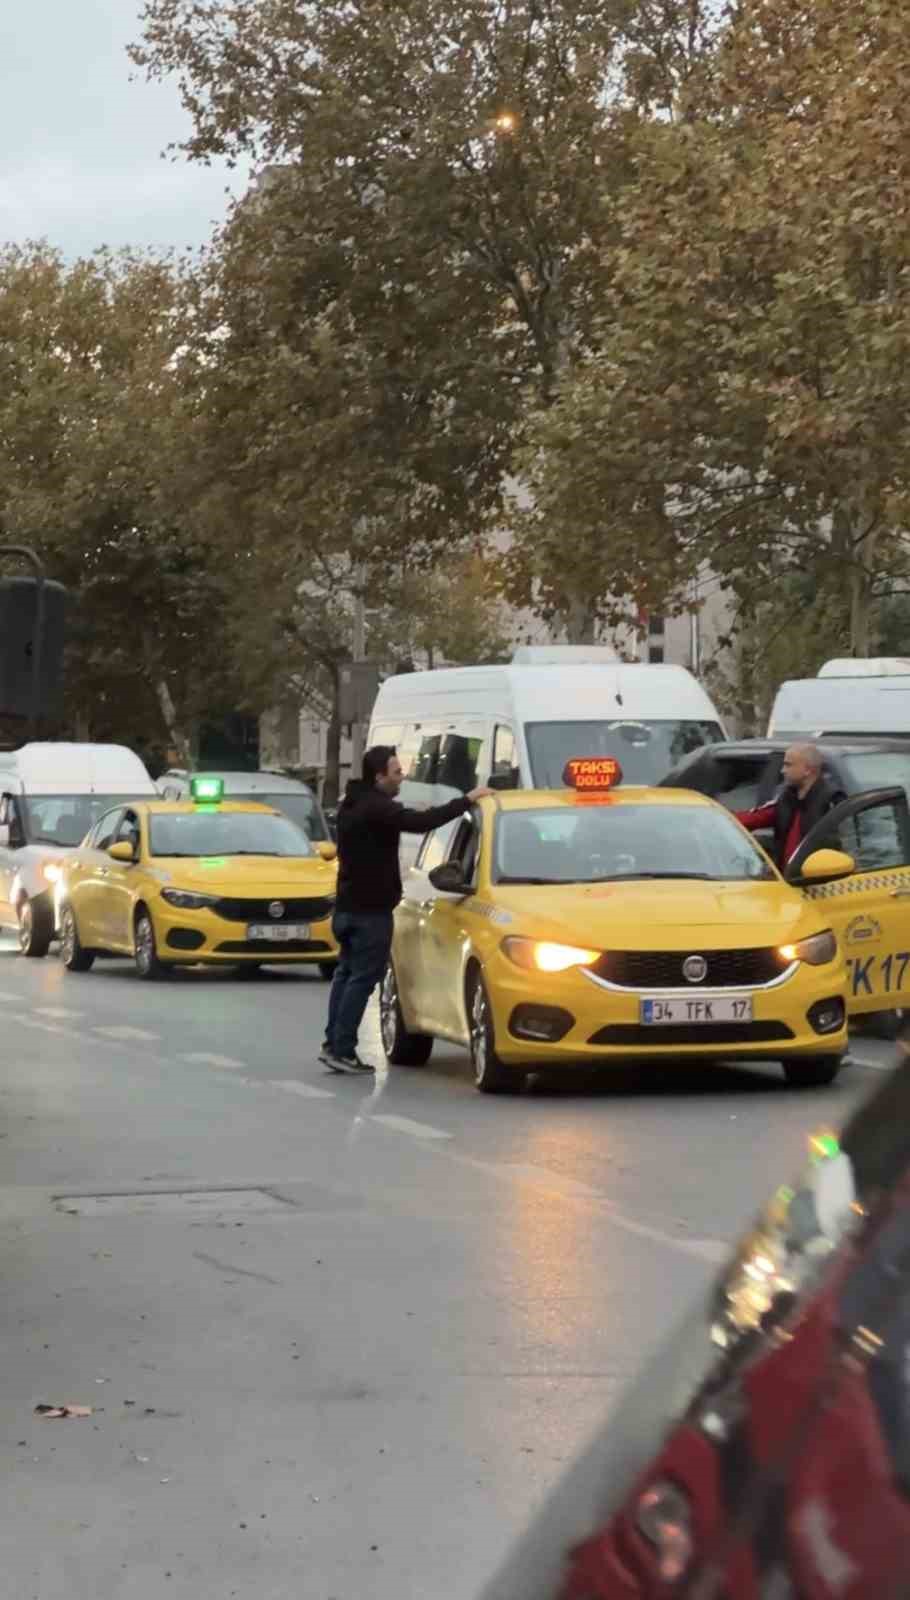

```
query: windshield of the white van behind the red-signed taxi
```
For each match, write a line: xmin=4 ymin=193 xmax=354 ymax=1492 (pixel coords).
xmin=525 ymin=717 xmax=723 ymax=789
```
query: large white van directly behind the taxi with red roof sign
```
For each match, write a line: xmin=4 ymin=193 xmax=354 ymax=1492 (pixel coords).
xmin=361 ymin=661 xmax=726 ymax=859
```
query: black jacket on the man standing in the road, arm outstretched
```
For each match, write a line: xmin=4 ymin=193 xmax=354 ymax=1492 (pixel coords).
xmin=336 ymin=778 xmax=470 ymax=912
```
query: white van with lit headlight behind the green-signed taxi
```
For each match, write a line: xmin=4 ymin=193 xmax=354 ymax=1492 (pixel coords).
xmin=0 ymin=742 xmax=157 ymax=955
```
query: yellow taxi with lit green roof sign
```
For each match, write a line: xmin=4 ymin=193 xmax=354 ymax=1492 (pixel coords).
xmin=56 ymin=778 xmax=337 ymax=979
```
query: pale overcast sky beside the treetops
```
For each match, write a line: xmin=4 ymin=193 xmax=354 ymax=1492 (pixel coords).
xmin=0 ymin=0 xmax=241 ymax=256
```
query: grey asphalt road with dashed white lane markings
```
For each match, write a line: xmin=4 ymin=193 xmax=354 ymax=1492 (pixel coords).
xmin=0 ymin=944 xmax=888 ymax=1600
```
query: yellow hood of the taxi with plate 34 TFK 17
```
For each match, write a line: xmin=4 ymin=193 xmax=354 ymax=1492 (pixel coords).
xmin=496 ymin=878 xmax=822 ymax=950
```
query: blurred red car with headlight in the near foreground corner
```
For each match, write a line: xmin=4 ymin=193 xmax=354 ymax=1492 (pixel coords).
xmin=488 ymin=1056 xmax=910 ymax=1600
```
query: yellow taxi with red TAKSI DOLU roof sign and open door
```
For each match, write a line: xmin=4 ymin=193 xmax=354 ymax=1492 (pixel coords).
xmin=381 ymin=758 xmax=910 ymax=1093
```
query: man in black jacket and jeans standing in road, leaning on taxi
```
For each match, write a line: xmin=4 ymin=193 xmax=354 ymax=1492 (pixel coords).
xmin=320 ymin=744 xmax=491 ymax=1072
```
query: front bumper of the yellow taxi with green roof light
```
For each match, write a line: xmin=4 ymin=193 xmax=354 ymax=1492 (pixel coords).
xmin=152 ymin=901 xmax=339 ymax=966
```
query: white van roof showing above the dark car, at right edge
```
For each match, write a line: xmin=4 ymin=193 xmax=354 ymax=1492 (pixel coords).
xmin=768 ymin=672 xmax=910 ymax=739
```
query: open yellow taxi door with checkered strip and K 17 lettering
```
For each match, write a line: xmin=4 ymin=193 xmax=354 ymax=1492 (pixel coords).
xmin=785 ymin=789 xmax=910 ymax=1016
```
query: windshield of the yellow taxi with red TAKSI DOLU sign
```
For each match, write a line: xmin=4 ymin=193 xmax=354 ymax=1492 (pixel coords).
xmin=494 ymin=805 xmax=774 ymax=883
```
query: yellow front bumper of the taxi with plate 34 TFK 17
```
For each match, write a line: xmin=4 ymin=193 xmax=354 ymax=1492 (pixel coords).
xmin=485 ymin=954 xmax=848 ymax=1066
